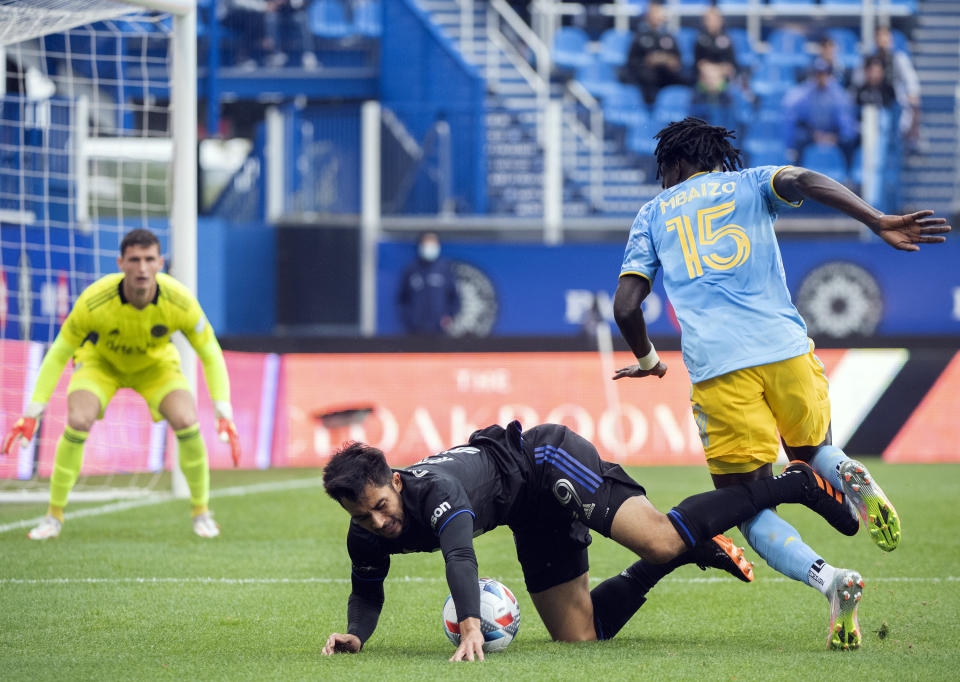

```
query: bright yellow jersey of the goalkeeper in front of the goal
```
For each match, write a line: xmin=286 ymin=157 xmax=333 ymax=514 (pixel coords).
xmin=60 ymin=272 xmax=213 ymax=374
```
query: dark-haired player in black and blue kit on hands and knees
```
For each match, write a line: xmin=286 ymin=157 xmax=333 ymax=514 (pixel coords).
xmin=323 ymin=422 xmax=850 ymax=661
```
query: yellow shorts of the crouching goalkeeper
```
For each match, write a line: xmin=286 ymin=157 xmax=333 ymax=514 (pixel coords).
xmin=67 ymin=358 xmax=190 ymax=422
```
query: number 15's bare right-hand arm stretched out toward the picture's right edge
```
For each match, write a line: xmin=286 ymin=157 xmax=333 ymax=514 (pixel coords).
xmin=773 ymin=166 xmax=950 ymax=251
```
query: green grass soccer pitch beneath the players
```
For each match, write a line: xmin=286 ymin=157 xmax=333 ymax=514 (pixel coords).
xmin=0 ymin=461 xmax=960 ymax=681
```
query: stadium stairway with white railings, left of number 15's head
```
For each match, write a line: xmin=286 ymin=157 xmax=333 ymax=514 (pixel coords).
xmin=417 ymin=0 xmax=655 ymax=218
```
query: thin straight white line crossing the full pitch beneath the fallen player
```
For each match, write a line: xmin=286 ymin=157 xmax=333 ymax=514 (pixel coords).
xmin=0 ymin=575 xmax=960 ymax=585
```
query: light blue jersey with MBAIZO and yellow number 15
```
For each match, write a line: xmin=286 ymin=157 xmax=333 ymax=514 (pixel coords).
xmin=620 ymin=166 xmax=810 ymax=383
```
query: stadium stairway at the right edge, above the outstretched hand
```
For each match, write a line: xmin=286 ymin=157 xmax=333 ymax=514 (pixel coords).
xmin=902 ymin=0 xmax=960 ymax=216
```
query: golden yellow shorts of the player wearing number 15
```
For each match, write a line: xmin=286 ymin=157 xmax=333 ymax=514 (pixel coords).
xmin=690 ymin=344 xmax=830 ymax=474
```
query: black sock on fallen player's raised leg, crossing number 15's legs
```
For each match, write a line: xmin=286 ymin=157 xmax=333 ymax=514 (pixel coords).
xmin=667 ymin=472 xmax=807 ymax=547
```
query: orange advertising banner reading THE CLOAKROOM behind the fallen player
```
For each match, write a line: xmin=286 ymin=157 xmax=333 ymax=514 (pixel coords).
xmin=282 ymin=352 xmax=800 ymax=466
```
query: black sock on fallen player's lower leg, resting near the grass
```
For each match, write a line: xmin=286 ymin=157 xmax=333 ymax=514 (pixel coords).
xmin=590 ymin=552 xmax=693 ymax=639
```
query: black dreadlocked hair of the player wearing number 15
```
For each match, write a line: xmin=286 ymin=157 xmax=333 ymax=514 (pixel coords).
xmin=654 ymin=116 xmax=743 ymax=179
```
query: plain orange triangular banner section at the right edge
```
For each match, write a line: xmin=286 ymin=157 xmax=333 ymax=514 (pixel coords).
xmin=883 ymin=353 xmax=960 ymax=462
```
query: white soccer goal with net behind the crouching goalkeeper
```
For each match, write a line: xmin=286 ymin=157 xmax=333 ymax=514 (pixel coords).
xmin=0 ymin=0 xmax=197 ymax=500
